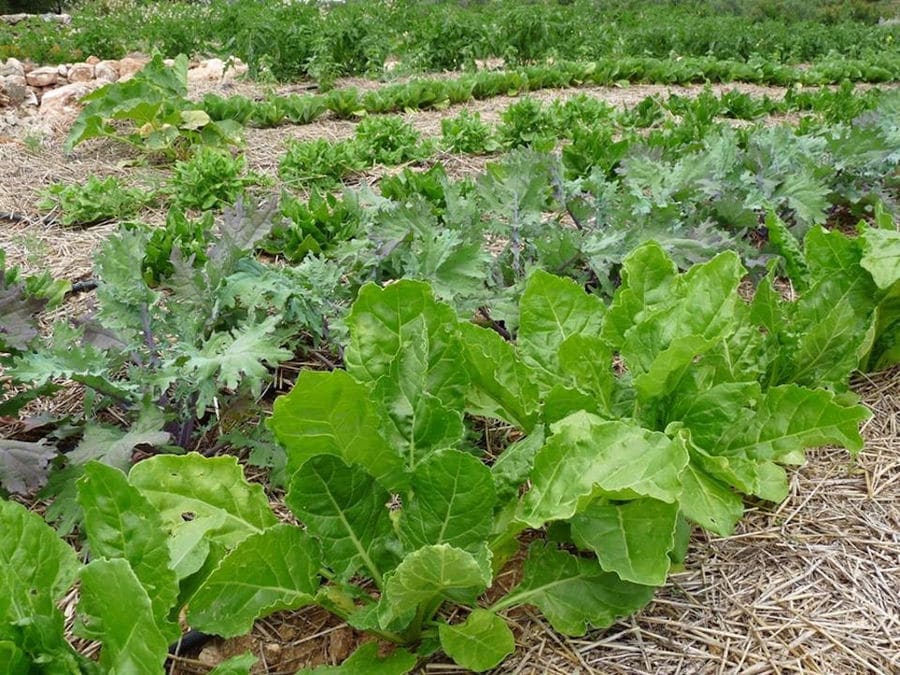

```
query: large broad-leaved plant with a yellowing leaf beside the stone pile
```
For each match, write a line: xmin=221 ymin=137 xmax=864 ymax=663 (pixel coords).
xmin=64 ymin=54 xmax=241 ymax=157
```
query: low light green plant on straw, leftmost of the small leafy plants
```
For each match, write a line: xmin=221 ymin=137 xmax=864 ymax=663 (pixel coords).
xmin=38 ymin=176 xmax=156 ymax=227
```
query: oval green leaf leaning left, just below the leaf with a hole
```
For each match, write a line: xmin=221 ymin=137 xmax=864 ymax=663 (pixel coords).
xmin=188 ymin=524 xmax=321 ymax=637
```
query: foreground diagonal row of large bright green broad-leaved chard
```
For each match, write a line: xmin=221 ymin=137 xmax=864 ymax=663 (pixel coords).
xmin=0 ymin=228 xmax=900 ymax=673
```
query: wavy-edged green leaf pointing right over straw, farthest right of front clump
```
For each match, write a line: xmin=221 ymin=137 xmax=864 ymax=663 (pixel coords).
xmin=708 ymin=384 xmax=871 ymax=461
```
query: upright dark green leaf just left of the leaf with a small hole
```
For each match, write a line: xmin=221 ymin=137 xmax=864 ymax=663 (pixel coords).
xmin=78 ymin=462 xmax=178 ymax=640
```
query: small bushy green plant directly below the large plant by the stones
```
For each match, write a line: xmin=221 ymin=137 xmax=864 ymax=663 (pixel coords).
xmin=164 ymin=147 xmax=264 ymax=211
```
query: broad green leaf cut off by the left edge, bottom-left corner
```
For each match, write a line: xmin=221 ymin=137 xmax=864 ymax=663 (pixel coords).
xmin=0 ymin=499 xmax=79 ymax=624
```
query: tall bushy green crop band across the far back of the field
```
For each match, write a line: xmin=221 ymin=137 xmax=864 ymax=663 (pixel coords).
xmin=0 ymin=0 xmax=898 ymax=81
